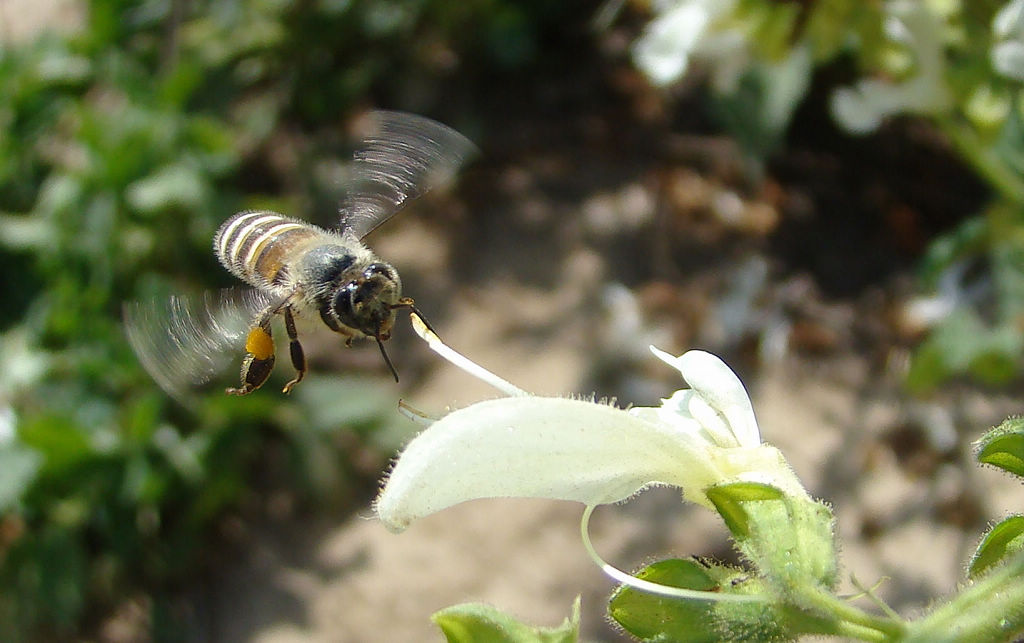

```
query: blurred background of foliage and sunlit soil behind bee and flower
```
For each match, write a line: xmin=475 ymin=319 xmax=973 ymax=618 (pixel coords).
xmin=0 ymin=0 xmax=1024 ymax=643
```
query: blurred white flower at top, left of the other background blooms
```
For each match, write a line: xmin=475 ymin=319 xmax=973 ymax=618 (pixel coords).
xmin=633 ymin=0 xmax=749 ymax=90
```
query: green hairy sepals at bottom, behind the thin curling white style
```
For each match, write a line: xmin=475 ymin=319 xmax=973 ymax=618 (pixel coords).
xmin=608 ymin=559 xmax=835 ymax=643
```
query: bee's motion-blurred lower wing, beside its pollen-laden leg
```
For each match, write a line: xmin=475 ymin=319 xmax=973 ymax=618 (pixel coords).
xmin=124 ymin=289 xmax=270 ymax=401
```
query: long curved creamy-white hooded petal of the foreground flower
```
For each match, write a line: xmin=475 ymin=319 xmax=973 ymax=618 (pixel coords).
xmin=376 ymin=397 xmax=720 ymax=531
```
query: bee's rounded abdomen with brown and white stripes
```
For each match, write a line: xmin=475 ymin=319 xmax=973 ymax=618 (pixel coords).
xmin=213 ymin=210 xmax=323 ymax=288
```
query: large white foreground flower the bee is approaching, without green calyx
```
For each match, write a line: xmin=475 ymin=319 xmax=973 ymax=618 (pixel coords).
xmin=376 ymin=316 xmax=806 ymax=531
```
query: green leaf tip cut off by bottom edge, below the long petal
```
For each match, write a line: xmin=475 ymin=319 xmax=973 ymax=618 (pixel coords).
xmin=430 ymin=597 xmax=580 ymax=643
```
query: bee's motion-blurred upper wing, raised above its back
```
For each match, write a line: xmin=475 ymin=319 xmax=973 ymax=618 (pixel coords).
xmin=341 ymin=112 xmax=476 ymax=239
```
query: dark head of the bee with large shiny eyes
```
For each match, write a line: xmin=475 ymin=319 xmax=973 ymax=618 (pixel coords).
xmin=331 ymin=262 xmax=401 ymax=340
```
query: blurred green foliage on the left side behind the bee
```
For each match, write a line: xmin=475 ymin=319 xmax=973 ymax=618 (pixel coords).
xmin=0 ymin=0 xmax=565 ymax=641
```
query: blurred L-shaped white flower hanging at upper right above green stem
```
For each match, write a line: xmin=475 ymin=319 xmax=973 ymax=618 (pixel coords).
xmin=831 ymin=0 xmax=952 ymax=133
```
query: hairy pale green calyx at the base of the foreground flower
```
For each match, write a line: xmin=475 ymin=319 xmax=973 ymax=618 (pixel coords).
xmin=705 ymin=482 xmax=838 ymax=593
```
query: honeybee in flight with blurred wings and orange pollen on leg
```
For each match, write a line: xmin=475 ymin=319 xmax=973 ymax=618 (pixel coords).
xmin=125 ymin=112 xmax=475 ymax=397
